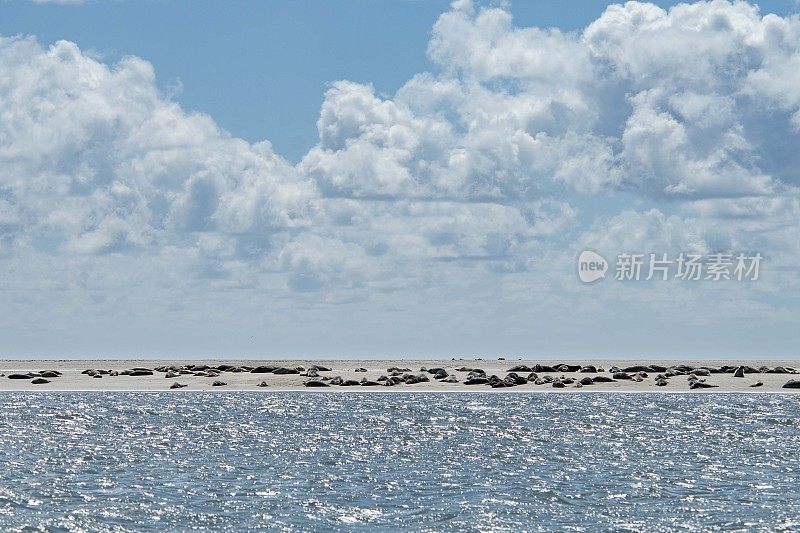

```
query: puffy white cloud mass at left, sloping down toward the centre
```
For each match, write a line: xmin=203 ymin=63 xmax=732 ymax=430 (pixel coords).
xmin=0 ymin=34 xmax=316 ymax=260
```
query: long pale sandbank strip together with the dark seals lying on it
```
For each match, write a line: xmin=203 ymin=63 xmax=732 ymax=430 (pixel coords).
xmin=0 ymin=359 xmax=800 ymax=393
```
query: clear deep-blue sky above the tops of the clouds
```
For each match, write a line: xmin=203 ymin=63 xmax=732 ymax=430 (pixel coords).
xmin=0 ymin=0 xmax=797 ymax=161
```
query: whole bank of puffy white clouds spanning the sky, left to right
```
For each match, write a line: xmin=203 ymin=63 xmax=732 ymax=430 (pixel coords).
xmin=0 ymin=1 xmax=800 ymax=354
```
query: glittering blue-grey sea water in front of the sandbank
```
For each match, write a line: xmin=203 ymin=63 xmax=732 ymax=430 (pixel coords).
xmin=0 ymin=392 xmax=800 ymax=532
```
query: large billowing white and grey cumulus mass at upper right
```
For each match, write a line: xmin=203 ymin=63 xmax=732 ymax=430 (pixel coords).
xmin=303 ymin=2 xmax=800 ymax=204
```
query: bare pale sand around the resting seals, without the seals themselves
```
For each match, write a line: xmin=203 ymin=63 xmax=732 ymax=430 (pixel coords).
xmin=0 ymin=359 xmax=800 ymax=393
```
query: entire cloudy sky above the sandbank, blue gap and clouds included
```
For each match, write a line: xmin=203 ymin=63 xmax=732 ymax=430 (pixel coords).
xmin=0 ymin=0 xmax=800 ymax=358
